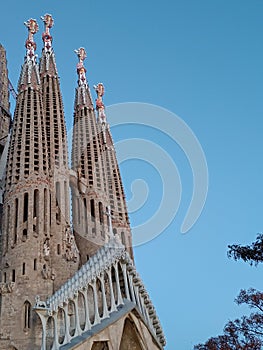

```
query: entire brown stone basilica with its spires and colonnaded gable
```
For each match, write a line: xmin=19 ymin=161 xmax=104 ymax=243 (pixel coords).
xmin=0 ymin=15 xmax=165 ymax=350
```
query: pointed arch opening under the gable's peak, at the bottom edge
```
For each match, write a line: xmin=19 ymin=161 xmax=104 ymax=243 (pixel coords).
xmin=119 ymin=318 xmax=146 ymax=350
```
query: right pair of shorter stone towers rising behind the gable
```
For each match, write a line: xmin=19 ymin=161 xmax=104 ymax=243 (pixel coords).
xmin=72 ymin=48 xmax=133 ymax=263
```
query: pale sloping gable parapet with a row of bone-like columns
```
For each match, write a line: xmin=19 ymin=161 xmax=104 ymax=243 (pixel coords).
xmin=34 ymin=237 xmax=165 ymax=350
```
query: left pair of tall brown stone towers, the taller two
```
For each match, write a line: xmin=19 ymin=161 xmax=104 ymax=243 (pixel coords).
xmin=0 ymin=17 xmax=79 ymax=349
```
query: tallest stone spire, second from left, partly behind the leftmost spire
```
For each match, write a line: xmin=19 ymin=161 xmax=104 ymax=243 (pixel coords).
xmin=40 ymin=14 xmax=79 ymax=289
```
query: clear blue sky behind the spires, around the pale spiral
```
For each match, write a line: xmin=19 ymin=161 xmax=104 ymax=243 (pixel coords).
xmin=0 ymin=0 xmax=263 ymax=350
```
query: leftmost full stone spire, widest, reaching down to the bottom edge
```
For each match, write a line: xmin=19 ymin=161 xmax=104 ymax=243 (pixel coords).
xmin=0 ymin=19 xmax=54 ymax=349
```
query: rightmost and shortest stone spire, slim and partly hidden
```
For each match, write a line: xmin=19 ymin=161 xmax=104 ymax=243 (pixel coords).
xmin=94 ymin=83 xmax=133 ymax=259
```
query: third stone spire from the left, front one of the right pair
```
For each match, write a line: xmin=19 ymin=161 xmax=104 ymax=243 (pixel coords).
xmin=71 ymin=48 xmax=109 ymax=263
